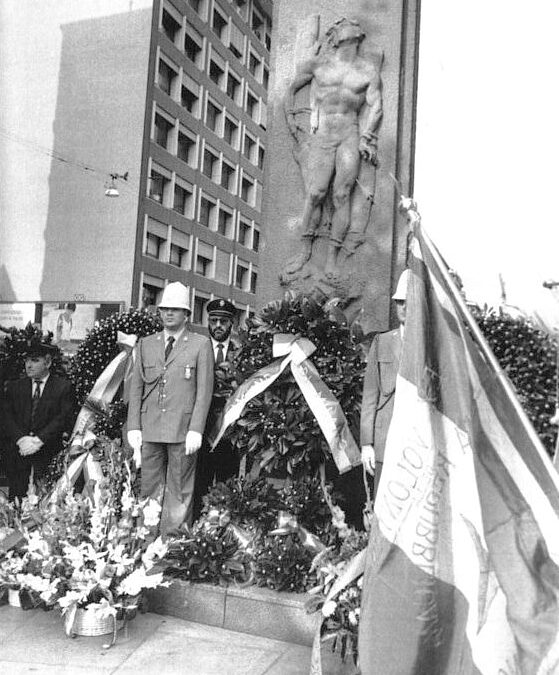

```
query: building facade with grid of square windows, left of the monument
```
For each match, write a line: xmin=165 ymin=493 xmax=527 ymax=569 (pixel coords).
xmin=132 ymin=0 xmax=271 ymax=324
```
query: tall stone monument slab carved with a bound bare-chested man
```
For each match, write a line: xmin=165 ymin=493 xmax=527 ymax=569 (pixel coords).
xmin=258 ymin=0 xmax=418 ymax=333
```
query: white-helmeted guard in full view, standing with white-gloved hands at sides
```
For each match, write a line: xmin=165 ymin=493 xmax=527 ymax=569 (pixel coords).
xmin=128 ymin=282 xmax=213 ymax=534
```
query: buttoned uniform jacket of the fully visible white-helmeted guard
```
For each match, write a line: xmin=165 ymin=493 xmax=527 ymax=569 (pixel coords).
xmin=128 ymin=330 xmax=214 ymax=443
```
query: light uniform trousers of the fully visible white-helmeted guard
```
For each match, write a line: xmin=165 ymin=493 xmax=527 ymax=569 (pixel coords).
xmin=141 ymin=442 xmax=198 ymax=535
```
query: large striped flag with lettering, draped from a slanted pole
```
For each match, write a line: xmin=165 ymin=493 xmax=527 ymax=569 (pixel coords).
xmin=359 ymin=223 xmax=559 ymax=675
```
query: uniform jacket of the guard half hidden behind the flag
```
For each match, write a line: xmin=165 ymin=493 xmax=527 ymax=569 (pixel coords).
xmin=361 ymin=328 xmax=402 ymax=462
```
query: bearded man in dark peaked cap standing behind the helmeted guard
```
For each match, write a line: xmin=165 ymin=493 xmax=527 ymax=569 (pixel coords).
xmin=194 ymin=298 xmax=239 ymax=518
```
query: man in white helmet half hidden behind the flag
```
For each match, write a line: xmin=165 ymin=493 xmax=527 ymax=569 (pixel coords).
xmin=361 ymin=270 xmax=409 ymax=495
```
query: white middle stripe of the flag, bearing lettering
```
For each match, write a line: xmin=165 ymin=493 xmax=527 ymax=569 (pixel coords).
xmin=375 ymin=376 xmax=514 ymax=673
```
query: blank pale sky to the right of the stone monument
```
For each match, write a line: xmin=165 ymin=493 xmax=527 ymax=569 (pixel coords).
xmin=415 ymin=0 xmax=559 ymax=320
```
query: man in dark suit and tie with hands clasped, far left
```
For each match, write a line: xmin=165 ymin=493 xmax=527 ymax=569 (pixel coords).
xmin=0 ymin=339 xmax=76 ymax=499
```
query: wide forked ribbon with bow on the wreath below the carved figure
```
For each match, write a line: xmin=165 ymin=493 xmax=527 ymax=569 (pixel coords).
xmin=212 ymin=333 xmax=361 ymax=473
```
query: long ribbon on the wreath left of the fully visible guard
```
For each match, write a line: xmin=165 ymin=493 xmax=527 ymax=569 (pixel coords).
xmin=53 ymin=331 xmax=138 ymax=497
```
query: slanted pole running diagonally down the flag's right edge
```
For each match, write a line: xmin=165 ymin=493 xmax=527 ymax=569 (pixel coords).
xmin=418 ymin=221 xmax=559 ymax=470
